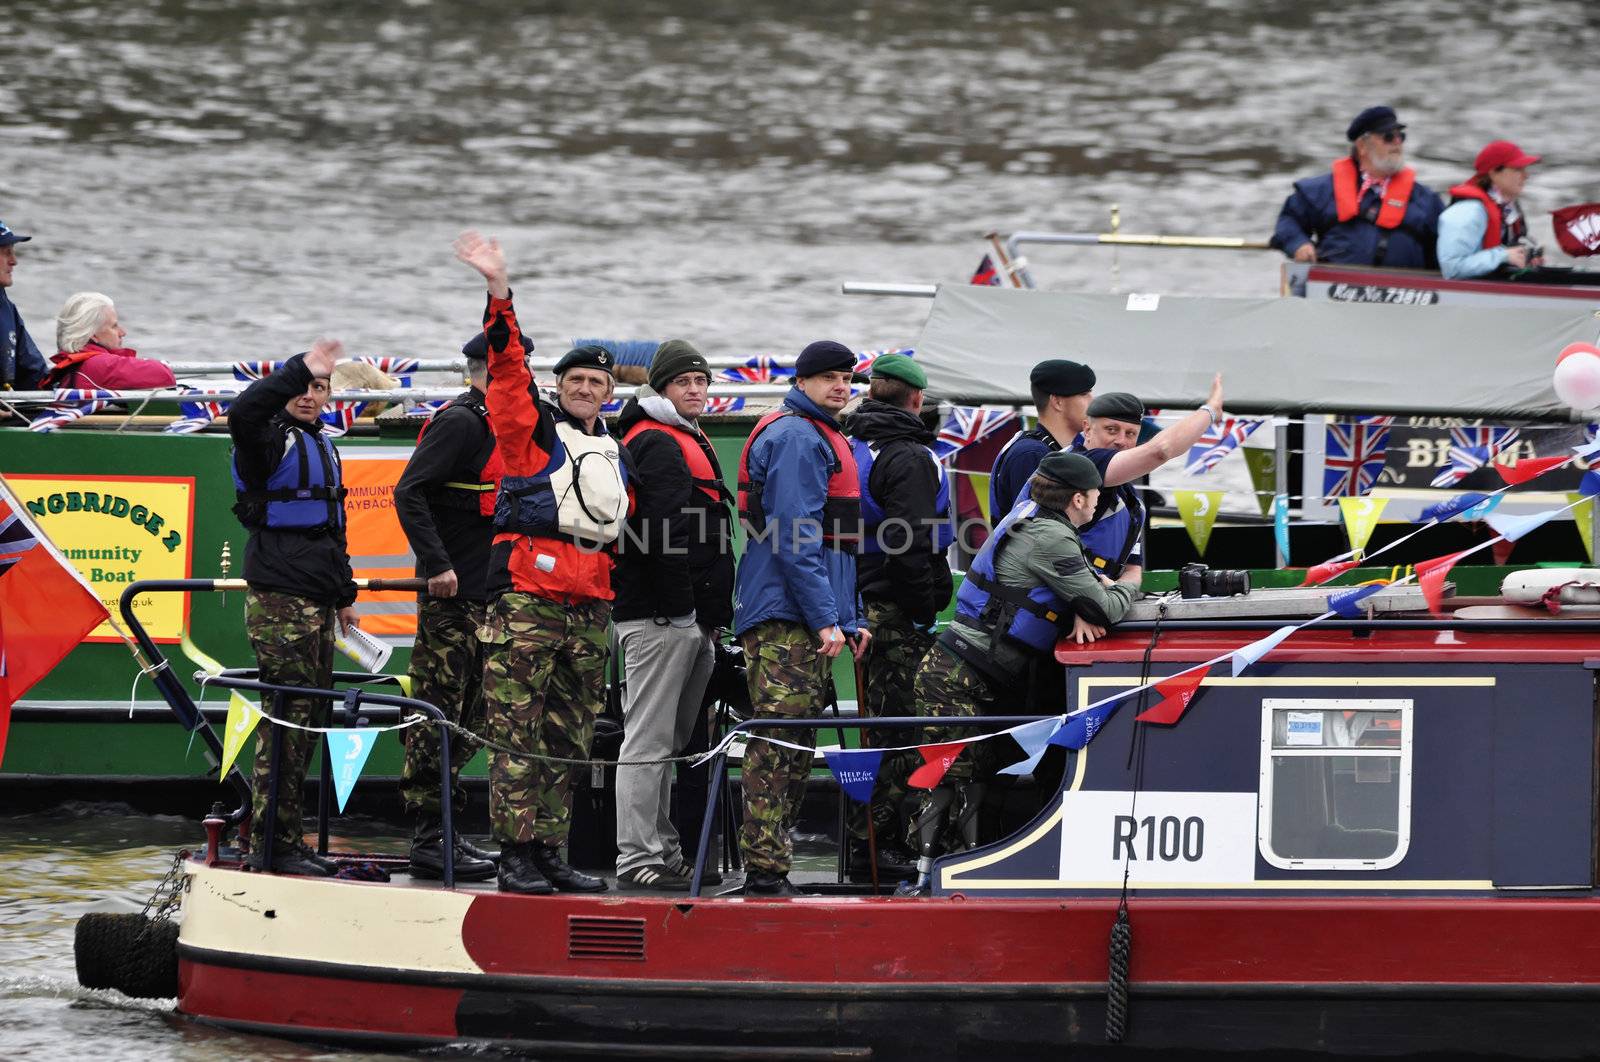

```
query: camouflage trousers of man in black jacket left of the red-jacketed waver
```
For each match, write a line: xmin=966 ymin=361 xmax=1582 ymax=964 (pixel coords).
xmin=400 ymin=597 xmax=485 ymax=832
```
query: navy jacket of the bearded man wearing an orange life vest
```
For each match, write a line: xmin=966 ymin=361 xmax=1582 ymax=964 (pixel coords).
xmin=1272 ymin=173 xmax=1445 ymax=269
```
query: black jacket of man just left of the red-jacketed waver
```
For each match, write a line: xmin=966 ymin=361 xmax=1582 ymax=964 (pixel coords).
xmin=395 ymin=389 xmax=494 ymax=601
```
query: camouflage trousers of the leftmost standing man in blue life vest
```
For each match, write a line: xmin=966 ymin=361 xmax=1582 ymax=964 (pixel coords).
xmin=245 ymin=590 xmax=338 ymax=851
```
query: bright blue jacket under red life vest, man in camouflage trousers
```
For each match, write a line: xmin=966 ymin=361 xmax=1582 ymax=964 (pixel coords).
xmin=733 ymin=387 xmax=856 ymax=635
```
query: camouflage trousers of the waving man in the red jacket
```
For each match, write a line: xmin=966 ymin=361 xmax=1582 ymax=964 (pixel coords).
xmin=478 ymin=593 xmax=611 ymax=846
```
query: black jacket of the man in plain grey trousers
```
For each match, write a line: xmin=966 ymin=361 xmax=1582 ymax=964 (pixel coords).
xmin=611 ymin=398 xmax=733 ymax=627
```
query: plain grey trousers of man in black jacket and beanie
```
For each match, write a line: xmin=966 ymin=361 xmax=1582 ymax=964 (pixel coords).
xmin=616 ymin=619 xmax=715 ymax=873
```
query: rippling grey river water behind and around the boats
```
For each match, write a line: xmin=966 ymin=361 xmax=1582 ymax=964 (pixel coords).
xmin=0 ymin=0 xmax=1600 ymax=1059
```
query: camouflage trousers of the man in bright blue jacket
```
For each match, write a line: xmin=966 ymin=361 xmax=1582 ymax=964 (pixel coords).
xmin=739 ymin=619 xmax=834 ymax=873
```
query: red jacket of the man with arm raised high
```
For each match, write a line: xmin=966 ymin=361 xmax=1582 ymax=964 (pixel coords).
xmin=483 ymin=296 xmax=614 ymax=603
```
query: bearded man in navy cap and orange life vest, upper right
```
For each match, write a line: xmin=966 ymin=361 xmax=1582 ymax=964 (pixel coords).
xmin=1272 ymin=107 xmax=1445 ymax=269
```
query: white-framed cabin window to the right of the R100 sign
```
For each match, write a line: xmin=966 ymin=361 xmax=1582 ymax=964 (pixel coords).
xmin=1256 ymin=697 xmax=1411 ymax=870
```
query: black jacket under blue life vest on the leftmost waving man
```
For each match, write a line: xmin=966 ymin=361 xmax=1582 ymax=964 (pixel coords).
xmin=227 ymin=355 xmax=355 ymax=608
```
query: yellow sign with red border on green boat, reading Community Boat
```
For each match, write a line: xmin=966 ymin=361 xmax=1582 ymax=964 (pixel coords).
xmin=6 ymin=475 xmax=195 ymax=641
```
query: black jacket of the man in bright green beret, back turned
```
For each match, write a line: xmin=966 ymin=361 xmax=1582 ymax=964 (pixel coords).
xmin=845 ymin=398 xmax=954 ymax=624
